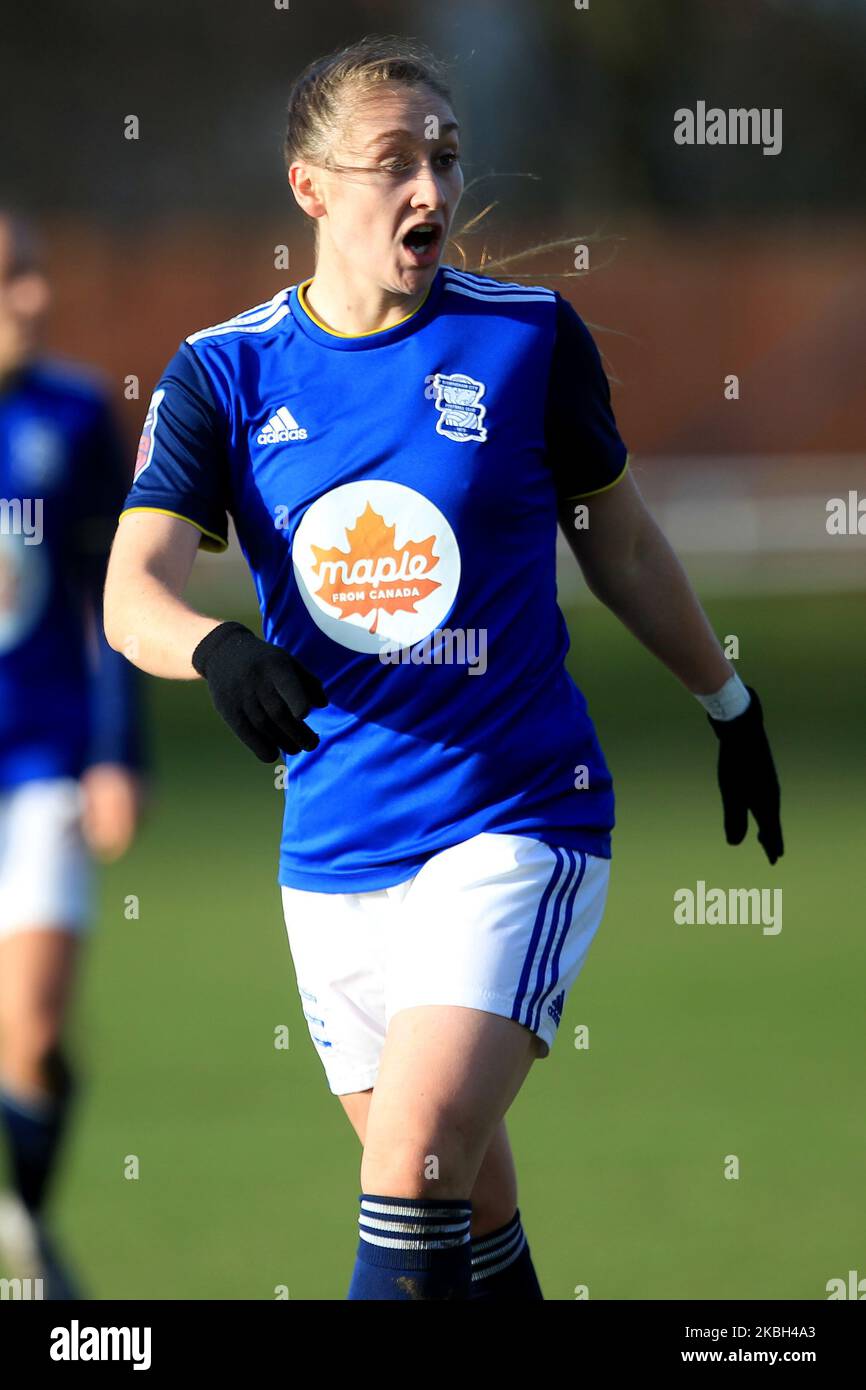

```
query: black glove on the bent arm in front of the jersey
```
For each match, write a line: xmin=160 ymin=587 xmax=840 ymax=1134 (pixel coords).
xmin=190 ymin=623 xmax=328 ymax=763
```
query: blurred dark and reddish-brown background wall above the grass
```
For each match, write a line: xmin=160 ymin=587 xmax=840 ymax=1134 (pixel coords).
xmin=0 ymin=0 xmax=866 ymax=608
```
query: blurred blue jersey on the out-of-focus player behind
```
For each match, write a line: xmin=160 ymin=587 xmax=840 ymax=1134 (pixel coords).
xmin=0 ymin=361 xmax=143 ymax=788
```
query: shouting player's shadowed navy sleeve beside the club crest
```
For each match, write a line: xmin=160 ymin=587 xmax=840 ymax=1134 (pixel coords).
xmin=545 ymin=292 xmax=628 ymax=500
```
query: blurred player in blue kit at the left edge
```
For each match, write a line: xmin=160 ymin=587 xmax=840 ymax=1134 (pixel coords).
xmin=0 ymin=209 xmax=143 ymax=1298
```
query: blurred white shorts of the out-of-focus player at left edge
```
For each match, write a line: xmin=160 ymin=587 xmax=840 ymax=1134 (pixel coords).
xmin=0 ymin=777 xmax=93 ymax=937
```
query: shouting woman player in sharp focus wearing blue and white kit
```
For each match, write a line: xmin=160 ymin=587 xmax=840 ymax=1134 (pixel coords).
xmin=106 ymin=39 xmax=781 ymax=1301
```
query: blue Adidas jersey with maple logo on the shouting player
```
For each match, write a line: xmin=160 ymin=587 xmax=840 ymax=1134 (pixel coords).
xmin=124 ymin=267 xmax=627 ymax=892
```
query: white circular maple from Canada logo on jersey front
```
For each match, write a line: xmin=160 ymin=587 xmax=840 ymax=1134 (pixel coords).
xmin=292 ymin=480 xmax=460 ymax=652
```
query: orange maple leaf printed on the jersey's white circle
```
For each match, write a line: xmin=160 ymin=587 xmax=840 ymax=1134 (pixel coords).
xmin=311 ymin=502 xmax=442 ymax=632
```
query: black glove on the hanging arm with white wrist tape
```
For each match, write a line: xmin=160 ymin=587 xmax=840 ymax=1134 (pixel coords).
xmin=706 ymin=685 xmax=784 ymax=865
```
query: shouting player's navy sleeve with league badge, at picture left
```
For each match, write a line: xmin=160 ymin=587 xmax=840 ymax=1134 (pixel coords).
xmin=121 ymin=343 xmax=229 ymax=552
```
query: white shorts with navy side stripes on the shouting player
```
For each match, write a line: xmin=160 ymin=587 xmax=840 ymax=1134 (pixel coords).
xmin=282 ymin=833 xmax=610 ymax=1095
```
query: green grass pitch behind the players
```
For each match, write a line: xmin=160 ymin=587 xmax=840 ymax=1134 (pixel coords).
xmin=13 ymin=595 xmax=866 ymax=1300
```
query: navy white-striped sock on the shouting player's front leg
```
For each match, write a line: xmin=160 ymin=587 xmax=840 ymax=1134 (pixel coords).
xmin=348 ymin=1193 xmax=473 ymax=1301
